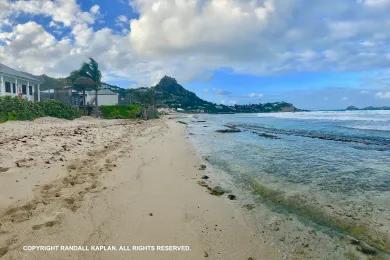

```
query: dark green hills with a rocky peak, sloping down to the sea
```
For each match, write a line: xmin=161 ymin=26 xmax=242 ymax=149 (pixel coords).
xmin=41 ymin=75 xmax=302 ymax=113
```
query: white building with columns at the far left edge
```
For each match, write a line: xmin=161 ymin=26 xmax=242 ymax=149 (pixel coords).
xmin=0 ymin=63 xmax=41 ymax=101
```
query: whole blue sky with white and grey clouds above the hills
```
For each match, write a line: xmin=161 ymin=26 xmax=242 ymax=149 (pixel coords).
xmin=0 ymin=0 xmax=390 ymax=109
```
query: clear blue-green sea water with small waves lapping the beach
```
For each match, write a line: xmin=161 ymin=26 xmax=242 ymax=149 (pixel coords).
xmin=188 ymin=111 xmax=390 ymax=250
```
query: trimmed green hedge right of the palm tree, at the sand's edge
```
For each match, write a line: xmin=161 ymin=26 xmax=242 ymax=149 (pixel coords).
xmin=100 ymin=104 xmax=142 ymax=119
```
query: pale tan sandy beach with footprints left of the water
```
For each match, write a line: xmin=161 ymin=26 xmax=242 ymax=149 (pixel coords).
xmin=0 ymin=118 xmax=280 ymax=260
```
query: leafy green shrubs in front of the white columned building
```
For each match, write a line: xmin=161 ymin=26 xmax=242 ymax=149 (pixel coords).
xmin=0 ymin=96 xmax=80 ymax=122
